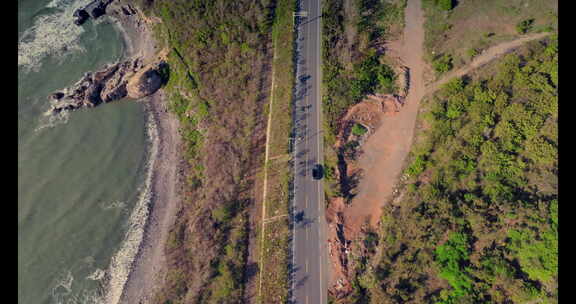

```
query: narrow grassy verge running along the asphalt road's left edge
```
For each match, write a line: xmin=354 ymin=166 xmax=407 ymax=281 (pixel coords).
xmin=259 ymin=0 xmax=296 ymax=303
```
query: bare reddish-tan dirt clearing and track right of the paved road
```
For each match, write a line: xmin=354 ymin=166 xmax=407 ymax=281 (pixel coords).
xmin=344 ymin=0 xmax=425 ymax=233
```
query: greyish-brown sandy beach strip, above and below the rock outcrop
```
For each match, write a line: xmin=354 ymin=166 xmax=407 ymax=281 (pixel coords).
xmin=110 ymin=2 xmax=180 ymax=303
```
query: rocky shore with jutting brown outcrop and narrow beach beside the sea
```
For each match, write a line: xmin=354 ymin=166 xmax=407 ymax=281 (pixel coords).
xmin=48 ymin=0 xmax=181 ymax=304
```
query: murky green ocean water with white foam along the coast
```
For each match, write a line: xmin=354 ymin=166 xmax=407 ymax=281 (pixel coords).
xmin=18 ymin=0 xmax=151 ymax=304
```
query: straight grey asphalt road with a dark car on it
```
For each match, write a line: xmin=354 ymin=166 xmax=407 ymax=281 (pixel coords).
xmin=292 ymin=0 xmax=328 ymax=304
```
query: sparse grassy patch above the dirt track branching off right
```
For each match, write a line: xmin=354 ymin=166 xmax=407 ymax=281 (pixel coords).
xmin=422 ymin=0 xmax=558 ymax=76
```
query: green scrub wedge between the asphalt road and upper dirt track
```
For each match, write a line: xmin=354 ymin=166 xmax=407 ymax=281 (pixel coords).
xmin=322 ymin=0 xmax=405 ymax=142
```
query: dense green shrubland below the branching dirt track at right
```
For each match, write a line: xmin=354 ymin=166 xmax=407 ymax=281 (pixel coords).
xmin=351 ymin=37 xmax=558 ymax=303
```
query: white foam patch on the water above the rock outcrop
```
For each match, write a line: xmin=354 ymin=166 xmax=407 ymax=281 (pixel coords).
xmin=18 ymin=0 xmax=90 ymax=69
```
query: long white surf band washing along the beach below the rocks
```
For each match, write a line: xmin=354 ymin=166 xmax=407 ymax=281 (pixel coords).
xmin=104 ymin=104 xmax=158 ymax=304
